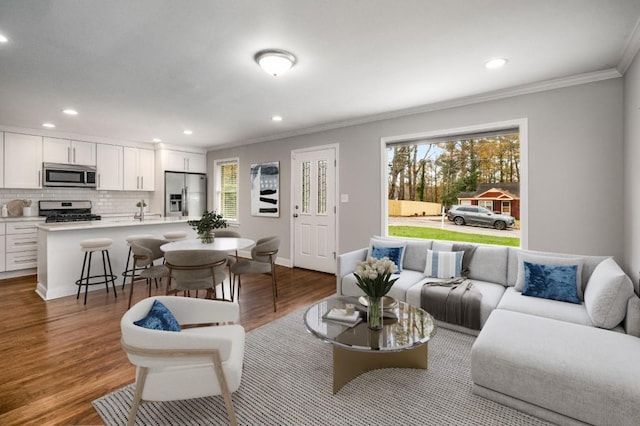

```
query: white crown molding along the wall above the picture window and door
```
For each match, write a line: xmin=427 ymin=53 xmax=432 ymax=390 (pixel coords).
xmin=207 ymin=68 xmax=622 ymax=151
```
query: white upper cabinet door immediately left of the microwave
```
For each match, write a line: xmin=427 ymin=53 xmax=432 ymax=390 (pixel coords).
xmin=4 ymin=132 xmax=42 ymax=188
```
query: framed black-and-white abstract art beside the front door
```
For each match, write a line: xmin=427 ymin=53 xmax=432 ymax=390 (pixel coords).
xmin=250 ymin=161 xmax=280 ymax=217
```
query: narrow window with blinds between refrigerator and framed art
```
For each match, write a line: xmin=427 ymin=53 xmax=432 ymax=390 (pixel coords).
xmin=213 ymin=158 xmax=239 ymax=222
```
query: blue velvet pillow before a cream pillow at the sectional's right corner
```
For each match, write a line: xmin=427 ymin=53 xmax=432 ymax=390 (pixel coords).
xmin=522 ymin=262 xmax=580 ymax=304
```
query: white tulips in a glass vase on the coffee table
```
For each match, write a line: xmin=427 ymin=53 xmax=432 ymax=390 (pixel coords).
xmin=353 ymin=257 xmax=399 ymax=330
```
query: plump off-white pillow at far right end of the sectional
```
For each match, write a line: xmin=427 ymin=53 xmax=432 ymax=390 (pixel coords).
xmin=584 ymin=258 xmax=633 ymax=329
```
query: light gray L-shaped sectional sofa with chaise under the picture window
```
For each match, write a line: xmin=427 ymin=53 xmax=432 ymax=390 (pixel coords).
xmin=337 ymin=237 xmax=640 ymax=425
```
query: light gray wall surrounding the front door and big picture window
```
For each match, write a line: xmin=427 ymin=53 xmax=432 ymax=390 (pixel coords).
xmin=207 ymin=78 xmax=624 ymax=262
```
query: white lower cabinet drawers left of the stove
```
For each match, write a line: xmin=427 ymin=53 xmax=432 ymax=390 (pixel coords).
xmin=5 ymin=221 xmax=39 ymax=271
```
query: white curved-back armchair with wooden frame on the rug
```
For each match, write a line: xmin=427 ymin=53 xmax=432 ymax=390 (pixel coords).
xmin=120 ymin=296 xmax=245 ymax=425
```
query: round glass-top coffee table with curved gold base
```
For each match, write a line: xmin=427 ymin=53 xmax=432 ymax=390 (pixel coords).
xmin=304 ymin=297 xmax=437 ymax=394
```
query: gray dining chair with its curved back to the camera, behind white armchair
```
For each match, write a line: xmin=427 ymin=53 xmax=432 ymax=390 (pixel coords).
xmin=164 ymin=250 xmax=227 ymax=299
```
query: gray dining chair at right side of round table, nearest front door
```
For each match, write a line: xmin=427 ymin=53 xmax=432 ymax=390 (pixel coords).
xmin=231 ymin=237 xmax=280 ymax=312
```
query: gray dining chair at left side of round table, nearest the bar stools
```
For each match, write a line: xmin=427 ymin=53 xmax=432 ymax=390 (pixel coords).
xmin=127 ymin=238 xmax=169 ymax=308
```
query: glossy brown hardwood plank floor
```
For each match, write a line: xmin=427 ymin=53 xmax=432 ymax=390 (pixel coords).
xmin=0 ymin=267 xmax=335 ymax=426
